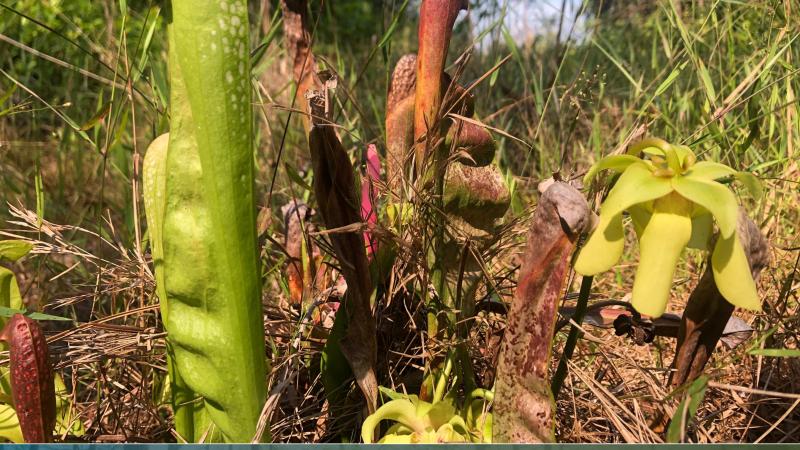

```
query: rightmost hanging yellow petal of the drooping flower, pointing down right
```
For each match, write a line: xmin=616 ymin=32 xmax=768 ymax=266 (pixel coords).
xmin=711 ymin=232 xmax=761 ymax=311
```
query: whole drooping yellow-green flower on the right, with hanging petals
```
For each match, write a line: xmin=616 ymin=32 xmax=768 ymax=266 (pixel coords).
xmin=575 ymin=138 xmax=761 ymax=317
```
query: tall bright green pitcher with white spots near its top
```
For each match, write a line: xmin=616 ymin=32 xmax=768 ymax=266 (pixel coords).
xmin=143 ymin=0 xmax=268 ymax=442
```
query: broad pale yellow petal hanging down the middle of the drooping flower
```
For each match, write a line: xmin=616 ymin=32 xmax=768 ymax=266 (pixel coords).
xmin=631 ymin=196 xmax=692 ymax=317
